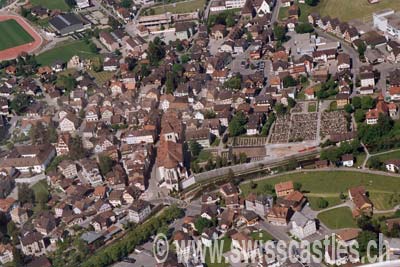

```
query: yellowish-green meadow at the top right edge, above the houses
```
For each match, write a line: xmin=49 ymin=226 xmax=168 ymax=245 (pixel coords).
xmin=299 ymin=0 xmax=400 ymax=21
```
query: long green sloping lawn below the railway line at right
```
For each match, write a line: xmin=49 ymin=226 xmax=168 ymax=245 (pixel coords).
xmin=240 ymin=171 xmax=400 ymax=210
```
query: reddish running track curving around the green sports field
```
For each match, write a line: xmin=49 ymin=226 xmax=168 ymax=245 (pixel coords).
xmin=0 ymin=14 xmax=43 ymax=61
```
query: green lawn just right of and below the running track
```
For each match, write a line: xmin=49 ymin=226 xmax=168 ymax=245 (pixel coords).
xmin=36 ymin=41 xmax=97 ymax=66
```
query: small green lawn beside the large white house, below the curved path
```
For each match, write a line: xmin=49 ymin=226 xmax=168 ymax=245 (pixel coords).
xmin=318 ymin=207 xmax=357 ymax=229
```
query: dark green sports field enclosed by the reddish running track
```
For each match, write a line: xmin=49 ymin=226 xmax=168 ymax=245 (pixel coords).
xmin=0 ymin=19 xmax=34 ymax=50
